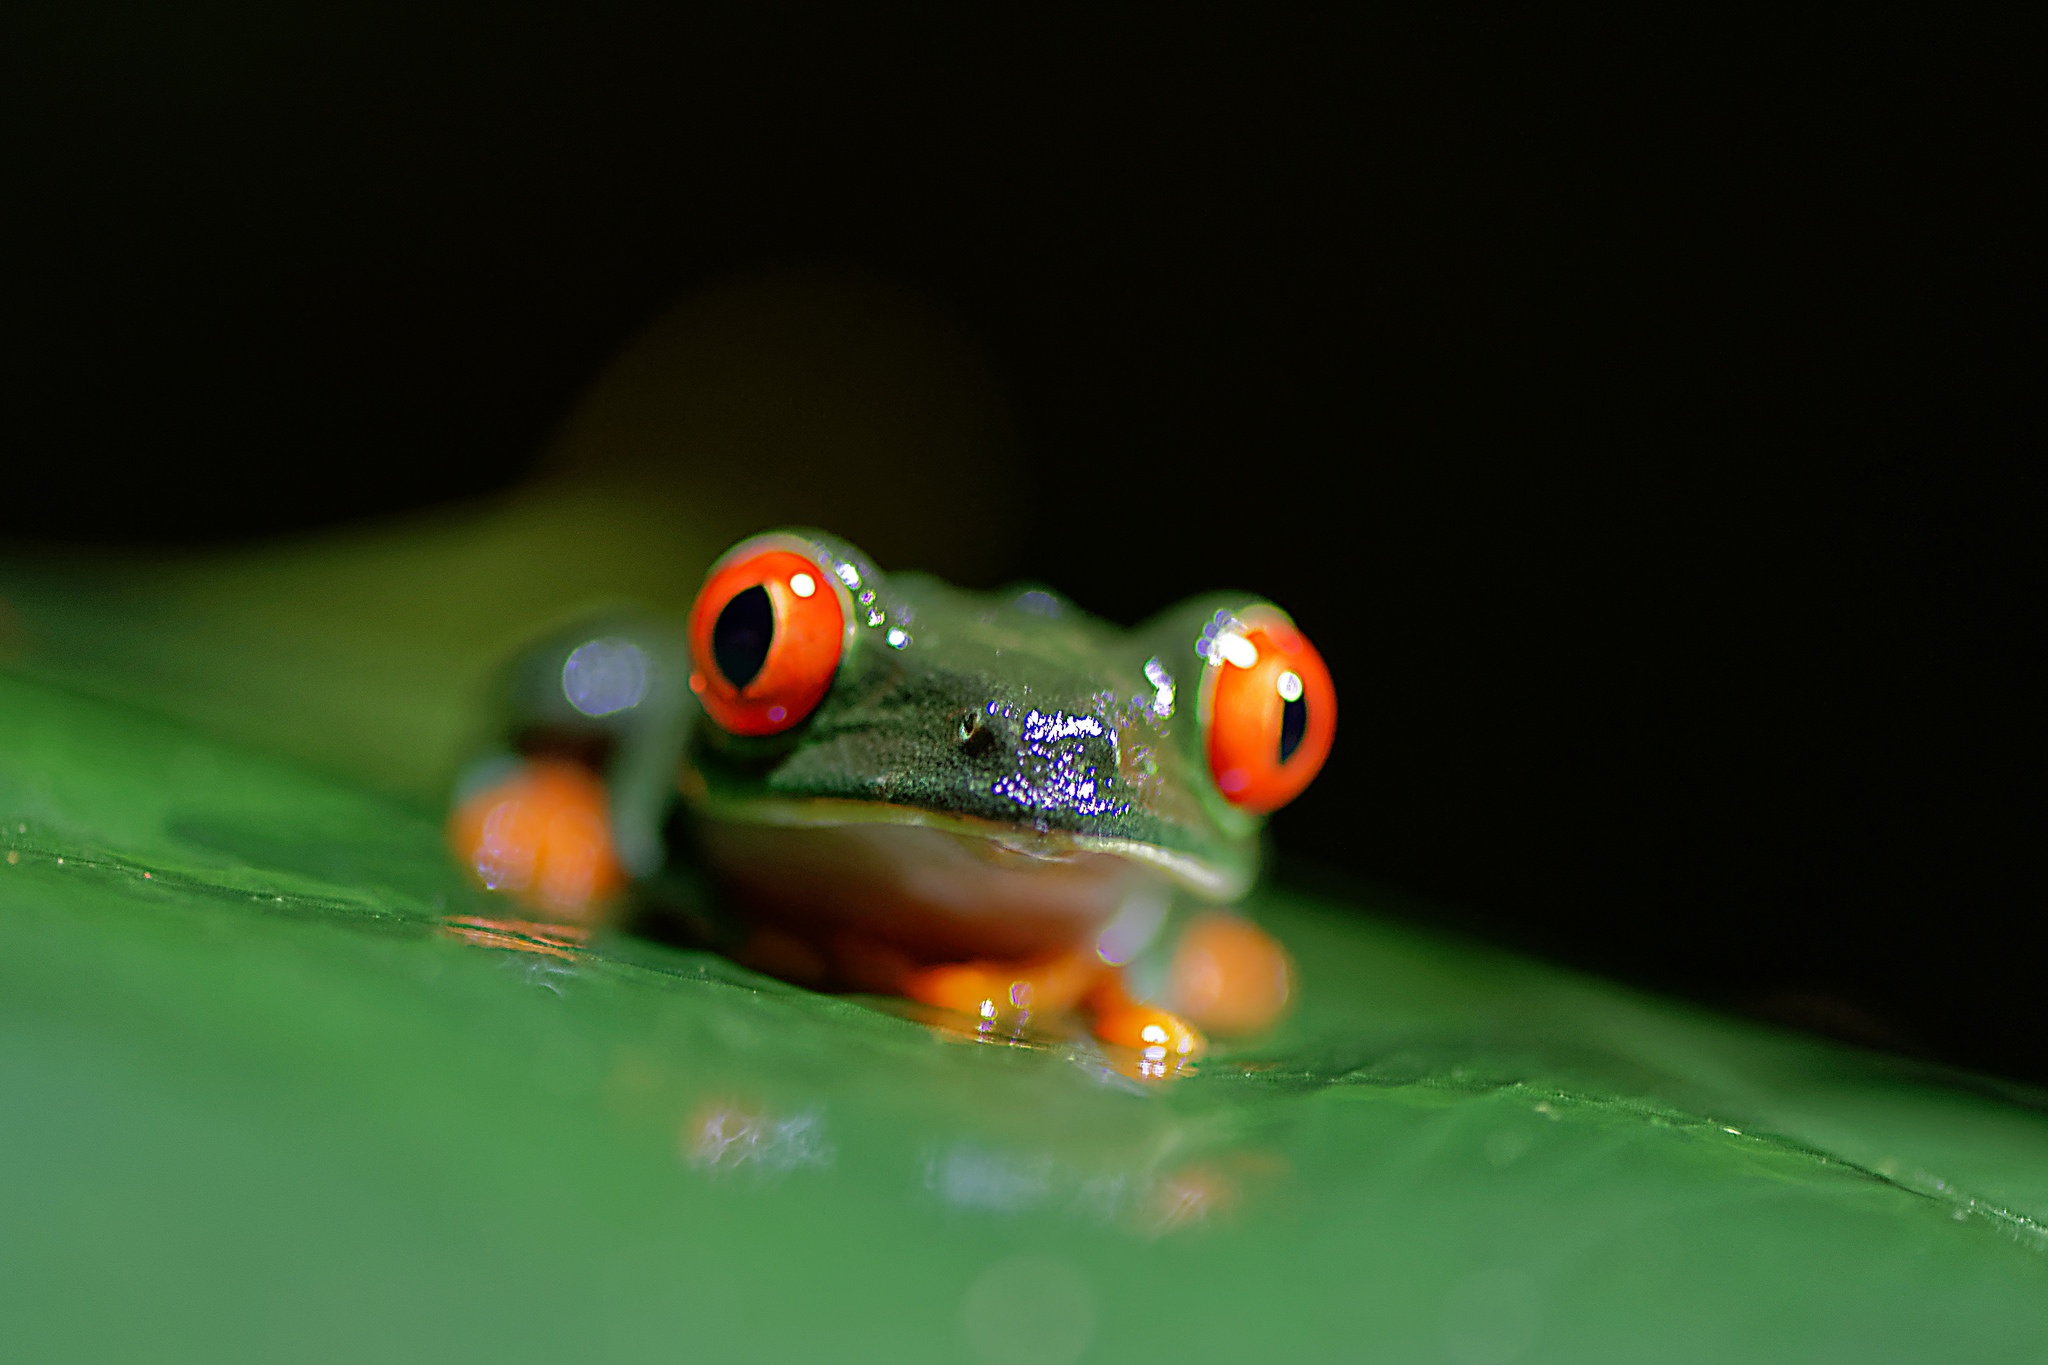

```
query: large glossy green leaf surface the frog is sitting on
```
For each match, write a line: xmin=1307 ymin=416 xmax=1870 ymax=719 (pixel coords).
xmin=0 ymin=675 xmax=2048 ymax=1365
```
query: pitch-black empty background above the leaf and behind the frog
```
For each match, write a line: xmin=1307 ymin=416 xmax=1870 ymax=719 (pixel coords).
xmin=0 ymin=4 xmax=2048 ymax=1078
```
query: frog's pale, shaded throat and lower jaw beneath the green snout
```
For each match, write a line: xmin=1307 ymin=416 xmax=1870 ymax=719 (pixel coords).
xmin=684 ymin=790 xmax=1249 ymax=960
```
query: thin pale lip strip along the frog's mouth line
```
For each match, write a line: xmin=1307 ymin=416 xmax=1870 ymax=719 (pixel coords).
xmin=684 ymin=782 xmax=1255 ymax=902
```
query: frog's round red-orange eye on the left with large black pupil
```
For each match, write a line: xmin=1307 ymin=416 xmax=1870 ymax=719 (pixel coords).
xmin=690 ymin=536 xmax=846 ymax=735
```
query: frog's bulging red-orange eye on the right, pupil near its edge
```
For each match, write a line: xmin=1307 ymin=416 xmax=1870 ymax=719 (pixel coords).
xmin=1200 ymin=608 xmax=1337 ymax=814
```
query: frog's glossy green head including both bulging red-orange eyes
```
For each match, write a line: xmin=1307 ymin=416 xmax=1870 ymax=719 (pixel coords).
xmin=682 ymin=530 xmax=1335 ymax=965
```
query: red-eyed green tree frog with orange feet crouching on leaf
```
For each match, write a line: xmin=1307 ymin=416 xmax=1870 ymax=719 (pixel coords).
xmin=449 ymin=528 xmax=1337 ymax=1072
